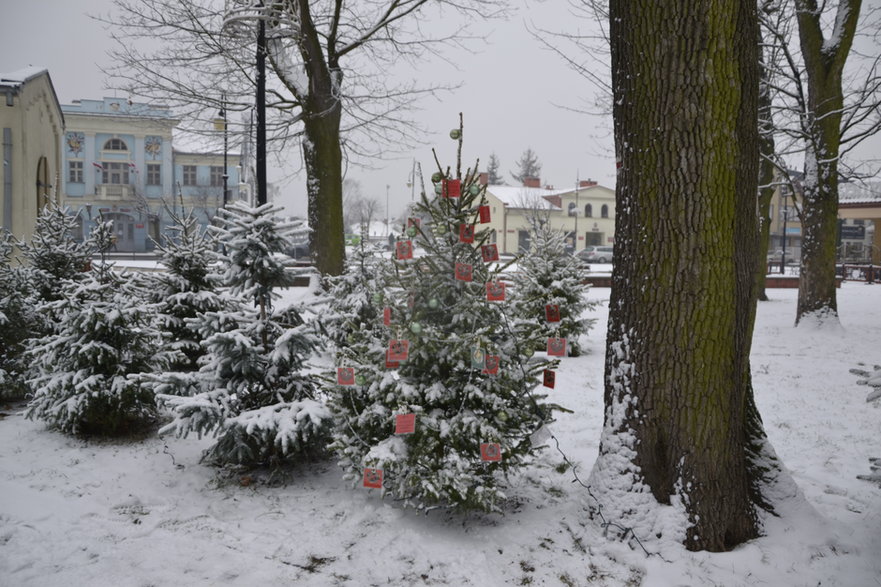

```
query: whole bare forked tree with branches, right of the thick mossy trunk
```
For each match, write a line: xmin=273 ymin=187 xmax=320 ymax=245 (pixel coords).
xmin=762 ymin=0 xmax=881 ymax=323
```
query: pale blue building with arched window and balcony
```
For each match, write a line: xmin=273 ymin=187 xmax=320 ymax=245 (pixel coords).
xmin=61 ymin=98 xmax=240 ymax=252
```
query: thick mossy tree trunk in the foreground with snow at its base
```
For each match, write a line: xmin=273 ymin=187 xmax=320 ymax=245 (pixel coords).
xmin=591 ymin=0 xmax=765 ymax=551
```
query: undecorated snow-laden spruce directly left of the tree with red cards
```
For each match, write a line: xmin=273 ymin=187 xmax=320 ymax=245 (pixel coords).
xmin=160 ymin=203 xmax=330 ymax=466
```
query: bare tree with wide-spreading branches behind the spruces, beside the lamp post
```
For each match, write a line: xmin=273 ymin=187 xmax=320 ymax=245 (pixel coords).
xmin=99 ymin=0 xmax=505 ymax=274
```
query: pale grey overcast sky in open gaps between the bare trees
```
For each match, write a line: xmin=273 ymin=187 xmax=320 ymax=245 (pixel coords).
xmin=0 ymin=0 xmax=881 ymax=217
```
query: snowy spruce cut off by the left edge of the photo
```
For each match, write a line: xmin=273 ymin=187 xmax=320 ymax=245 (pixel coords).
xmin=0 ymin=231 xmax=42 ymax=400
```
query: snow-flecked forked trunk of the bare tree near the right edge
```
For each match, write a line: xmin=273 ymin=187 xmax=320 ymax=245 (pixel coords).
xmin=795 ymin=0 xmax=861 ymax=324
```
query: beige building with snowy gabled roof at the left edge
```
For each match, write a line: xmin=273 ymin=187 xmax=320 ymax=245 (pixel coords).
xmin=0 ymin=68 xmax=64 ymax=240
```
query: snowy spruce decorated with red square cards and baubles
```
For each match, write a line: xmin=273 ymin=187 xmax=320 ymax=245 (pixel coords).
xmin=330 ymin=120 xmax=555 ymax=511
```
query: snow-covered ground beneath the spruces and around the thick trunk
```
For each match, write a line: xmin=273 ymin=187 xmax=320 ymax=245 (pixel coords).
xmin=0 ymin=282 xmax=881 ymax=587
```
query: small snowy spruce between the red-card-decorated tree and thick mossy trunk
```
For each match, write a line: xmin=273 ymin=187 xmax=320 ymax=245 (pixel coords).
xmin=511 ymin=218 xmax=596 ymax=357
